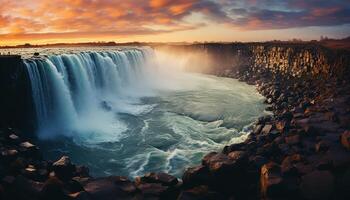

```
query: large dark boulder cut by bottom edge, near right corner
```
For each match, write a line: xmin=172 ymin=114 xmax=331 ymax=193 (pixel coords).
xmin=300 ymin=170 xmax=335 ymax=199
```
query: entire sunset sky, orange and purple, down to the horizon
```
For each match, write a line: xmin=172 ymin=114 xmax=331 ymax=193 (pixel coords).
xmin=0 ymin=0 xmax=350 ymax=45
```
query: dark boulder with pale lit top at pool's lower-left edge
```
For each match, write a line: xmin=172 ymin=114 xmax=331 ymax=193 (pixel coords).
xmin=52 ymin=156 xmax=75 ymax=181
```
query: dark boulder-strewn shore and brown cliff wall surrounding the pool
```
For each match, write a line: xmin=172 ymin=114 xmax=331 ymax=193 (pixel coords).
xmin=0 ymin=43 xmax=350 ymax=199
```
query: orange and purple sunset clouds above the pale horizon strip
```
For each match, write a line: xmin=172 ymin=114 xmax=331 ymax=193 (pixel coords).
xmin=0 ymin=0 xmax=350 ymax=42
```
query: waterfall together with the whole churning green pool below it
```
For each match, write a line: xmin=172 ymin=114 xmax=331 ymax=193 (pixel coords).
xmin=19 ymin=47 xmax=264 ymax=176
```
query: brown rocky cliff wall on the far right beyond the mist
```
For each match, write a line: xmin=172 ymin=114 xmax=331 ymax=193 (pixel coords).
xmin=155 ymin=43 xmax=350 ymax=79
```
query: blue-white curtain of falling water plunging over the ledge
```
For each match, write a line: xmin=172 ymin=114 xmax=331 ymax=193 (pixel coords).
xmin=24 ymin=48 xmax=154 ymax=142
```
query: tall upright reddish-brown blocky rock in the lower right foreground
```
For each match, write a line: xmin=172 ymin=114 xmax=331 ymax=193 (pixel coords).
xmin=260 ymin=162 xmax=284 ymax=198
